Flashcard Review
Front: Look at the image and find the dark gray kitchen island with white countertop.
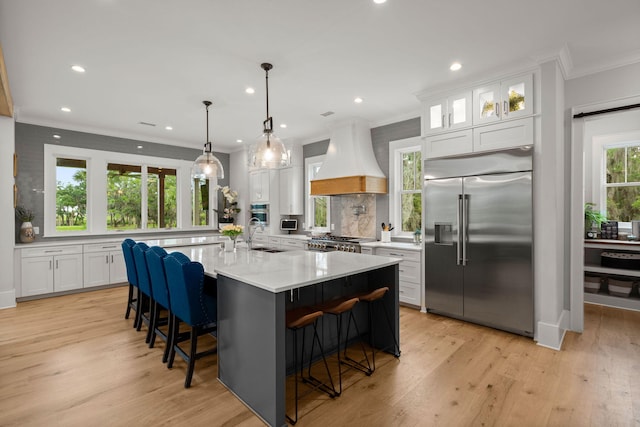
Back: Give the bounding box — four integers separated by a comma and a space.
170, 246, 401, 426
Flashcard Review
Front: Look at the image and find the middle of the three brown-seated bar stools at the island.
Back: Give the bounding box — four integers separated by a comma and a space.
317, 297, 373, 396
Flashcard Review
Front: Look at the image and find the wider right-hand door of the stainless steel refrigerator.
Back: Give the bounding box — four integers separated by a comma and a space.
464, 172, 533, 336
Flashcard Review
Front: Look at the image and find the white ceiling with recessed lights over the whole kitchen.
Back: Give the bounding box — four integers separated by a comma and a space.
0, 0, 640, 151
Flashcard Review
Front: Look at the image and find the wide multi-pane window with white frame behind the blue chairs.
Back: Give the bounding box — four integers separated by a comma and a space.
43, 144, 217, 237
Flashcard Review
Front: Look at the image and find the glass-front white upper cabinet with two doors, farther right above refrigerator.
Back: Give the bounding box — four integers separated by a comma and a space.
473, 74, 533, 125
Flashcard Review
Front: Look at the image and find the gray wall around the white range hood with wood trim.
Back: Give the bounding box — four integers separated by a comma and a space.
302, 117, 420, 239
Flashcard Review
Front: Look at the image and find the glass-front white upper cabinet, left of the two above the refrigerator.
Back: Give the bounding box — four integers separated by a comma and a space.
422, 91, 472, 136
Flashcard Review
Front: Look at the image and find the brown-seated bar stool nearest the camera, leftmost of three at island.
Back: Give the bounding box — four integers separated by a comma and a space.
286, 307, 335, 424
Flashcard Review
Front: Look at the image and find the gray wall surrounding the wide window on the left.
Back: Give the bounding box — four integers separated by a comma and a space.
15, 123, 229, 242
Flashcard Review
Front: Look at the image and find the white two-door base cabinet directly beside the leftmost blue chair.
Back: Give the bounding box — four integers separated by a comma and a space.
83, 243, 127, 288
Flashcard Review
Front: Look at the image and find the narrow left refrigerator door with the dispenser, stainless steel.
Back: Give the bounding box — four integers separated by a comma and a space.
425, 178, 463, 316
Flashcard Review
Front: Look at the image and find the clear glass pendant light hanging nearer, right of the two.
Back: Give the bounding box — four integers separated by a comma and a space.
249, 63, 289, 169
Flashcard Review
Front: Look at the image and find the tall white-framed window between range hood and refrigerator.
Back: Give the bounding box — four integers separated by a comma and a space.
389, 138, 422, 237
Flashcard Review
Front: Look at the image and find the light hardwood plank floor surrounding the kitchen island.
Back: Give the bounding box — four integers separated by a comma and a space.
0, 287, 640, 426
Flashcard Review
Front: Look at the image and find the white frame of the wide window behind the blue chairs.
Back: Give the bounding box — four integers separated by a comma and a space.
43, 144, 218, 237
